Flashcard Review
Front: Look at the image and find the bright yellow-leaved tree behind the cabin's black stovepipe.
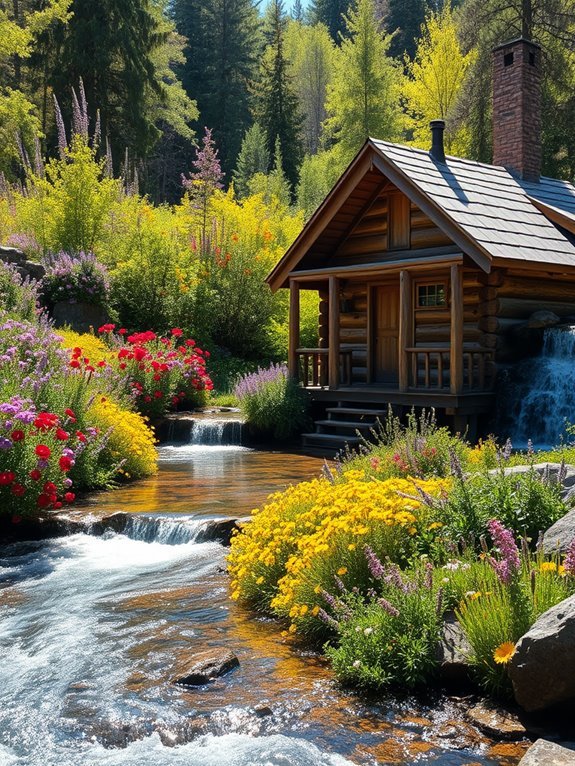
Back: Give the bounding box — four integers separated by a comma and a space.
402, 3, 475, 156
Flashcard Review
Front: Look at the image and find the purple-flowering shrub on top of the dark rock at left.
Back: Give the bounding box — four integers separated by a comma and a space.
40, 252, 110, 306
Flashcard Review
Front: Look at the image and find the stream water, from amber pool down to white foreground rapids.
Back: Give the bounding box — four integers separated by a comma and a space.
0, 424, 519, 766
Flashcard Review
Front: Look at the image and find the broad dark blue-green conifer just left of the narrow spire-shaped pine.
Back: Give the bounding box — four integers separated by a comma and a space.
173, 0, 260, 173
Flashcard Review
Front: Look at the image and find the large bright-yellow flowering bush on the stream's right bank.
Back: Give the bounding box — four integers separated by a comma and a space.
228, 470, 450, 632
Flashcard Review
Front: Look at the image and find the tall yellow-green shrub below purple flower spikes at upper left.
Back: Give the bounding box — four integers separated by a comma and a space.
18, 136, 120, 253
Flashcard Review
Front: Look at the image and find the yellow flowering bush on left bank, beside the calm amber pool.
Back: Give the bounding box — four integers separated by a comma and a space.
88, 396, 158, 479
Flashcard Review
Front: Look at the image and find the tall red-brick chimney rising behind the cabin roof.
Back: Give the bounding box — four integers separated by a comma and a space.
493, 38, 541, 182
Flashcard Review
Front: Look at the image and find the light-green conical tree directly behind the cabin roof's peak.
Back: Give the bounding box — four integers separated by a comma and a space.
326, 0, 401, 160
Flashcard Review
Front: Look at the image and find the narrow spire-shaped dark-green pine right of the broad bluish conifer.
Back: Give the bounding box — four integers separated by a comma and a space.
255, 0, 301, 187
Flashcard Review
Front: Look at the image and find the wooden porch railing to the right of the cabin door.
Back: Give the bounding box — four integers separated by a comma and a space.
406, 347, 494, 391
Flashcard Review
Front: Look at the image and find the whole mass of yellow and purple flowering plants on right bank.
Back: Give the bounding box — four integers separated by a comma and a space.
228, 413, 575, 700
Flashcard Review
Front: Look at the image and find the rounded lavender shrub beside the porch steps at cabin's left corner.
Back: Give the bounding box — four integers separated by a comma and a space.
234, 364, 307, 439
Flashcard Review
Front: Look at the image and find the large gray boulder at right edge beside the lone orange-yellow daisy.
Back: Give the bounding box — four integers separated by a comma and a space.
508, 596, 575, 713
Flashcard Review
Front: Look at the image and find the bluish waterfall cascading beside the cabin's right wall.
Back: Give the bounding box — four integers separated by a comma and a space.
511, 326, 575, 448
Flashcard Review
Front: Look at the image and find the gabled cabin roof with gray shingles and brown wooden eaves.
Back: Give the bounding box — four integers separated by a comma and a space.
267, 139, 575, 289
